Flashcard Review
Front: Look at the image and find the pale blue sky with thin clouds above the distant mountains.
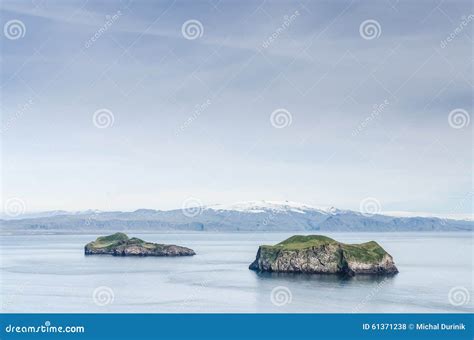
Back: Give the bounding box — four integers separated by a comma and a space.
0, 0, 474, 214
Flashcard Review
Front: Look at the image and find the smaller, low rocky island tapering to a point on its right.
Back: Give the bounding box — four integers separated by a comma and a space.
84, 233, 196, 256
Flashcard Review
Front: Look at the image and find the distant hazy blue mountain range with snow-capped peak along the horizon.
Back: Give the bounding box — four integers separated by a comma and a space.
0, 201, 474, 233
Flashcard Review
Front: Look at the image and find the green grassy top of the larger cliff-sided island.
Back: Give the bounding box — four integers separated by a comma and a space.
262, 235, 387, 262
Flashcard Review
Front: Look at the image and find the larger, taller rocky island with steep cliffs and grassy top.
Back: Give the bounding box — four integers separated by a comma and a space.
249, 235, 398, 276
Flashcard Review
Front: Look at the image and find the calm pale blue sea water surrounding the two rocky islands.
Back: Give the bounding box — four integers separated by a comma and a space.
0, 233, 474, 313
